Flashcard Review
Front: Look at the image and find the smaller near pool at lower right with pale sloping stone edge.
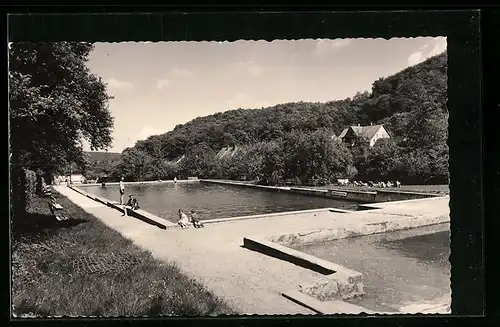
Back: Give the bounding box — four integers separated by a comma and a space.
294, 224, 451, 312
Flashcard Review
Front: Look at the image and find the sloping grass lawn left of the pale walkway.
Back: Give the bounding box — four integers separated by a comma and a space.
12, 194, 235, 316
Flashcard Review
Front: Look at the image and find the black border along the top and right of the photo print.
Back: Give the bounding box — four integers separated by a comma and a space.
8, 7, 485, 325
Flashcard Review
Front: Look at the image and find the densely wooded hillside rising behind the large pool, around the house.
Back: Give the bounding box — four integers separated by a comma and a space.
107, 52, 448, 183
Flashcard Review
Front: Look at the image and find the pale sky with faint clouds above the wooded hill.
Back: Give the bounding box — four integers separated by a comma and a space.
85, 37, 446, 152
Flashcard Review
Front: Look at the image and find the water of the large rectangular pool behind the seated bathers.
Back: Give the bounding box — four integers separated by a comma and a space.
82, 182, 358, 222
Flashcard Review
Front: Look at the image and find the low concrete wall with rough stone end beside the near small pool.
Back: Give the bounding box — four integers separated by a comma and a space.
243, 237, 364, 301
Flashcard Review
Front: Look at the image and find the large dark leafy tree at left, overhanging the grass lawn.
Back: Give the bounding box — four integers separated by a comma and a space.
9, 42, 113, 179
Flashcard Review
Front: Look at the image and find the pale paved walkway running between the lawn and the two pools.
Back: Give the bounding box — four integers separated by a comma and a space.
55, 186, 449, 314
